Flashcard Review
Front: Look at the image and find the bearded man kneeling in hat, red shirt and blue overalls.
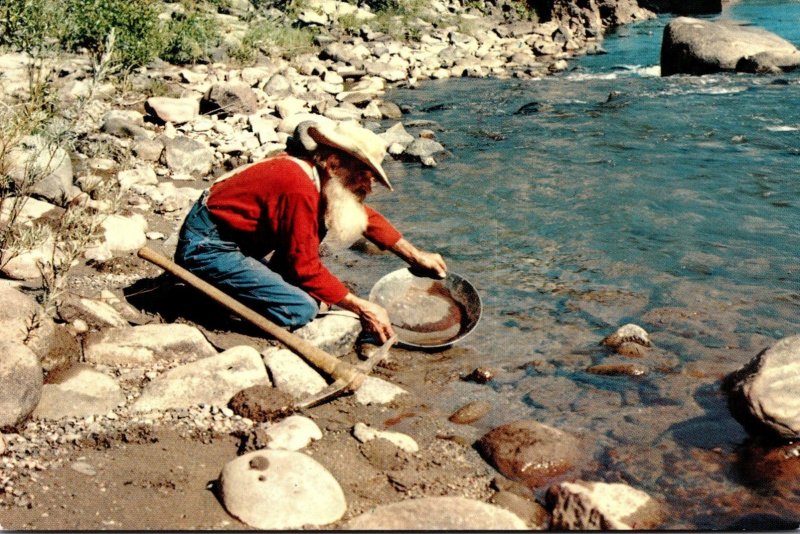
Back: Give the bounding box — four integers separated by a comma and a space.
175, 122, 447, 342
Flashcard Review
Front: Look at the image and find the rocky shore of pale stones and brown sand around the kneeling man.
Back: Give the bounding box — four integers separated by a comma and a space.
0, 0, 798, 530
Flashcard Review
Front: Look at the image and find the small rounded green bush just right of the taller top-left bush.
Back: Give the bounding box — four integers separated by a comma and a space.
161, 10, 221, 64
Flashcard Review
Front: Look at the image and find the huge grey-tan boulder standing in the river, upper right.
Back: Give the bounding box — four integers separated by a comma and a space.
661, 17, 800, 76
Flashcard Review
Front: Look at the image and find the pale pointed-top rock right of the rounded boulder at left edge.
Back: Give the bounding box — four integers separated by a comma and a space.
33, 364, 125, 419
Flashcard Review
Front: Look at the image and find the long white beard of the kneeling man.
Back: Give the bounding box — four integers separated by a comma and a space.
322, 176, 367, 250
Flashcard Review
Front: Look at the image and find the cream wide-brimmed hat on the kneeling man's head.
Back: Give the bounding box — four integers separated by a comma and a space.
294, 121, 394, 191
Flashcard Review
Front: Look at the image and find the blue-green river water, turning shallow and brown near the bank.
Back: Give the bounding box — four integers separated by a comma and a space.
346, 0, 800, 529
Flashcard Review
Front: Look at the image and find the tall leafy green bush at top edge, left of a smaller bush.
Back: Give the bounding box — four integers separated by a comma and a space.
62, 0, 163, 69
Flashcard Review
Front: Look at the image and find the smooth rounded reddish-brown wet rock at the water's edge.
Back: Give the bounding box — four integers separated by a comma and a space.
476, 420, 582, 488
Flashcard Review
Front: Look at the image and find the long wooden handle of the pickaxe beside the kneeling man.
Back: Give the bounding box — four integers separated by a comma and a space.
138, 247, 365, 389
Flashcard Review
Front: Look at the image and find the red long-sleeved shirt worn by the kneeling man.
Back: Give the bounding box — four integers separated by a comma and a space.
207, 156, 402, 304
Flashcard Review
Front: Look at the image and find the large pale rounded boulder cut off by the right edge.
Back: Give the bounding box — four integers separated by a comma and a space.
723, 335, 800, 439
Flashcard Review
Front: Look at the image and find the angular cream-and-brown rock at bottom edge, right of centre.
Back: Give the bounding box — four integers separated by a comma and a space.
547, 481, 662, 530
